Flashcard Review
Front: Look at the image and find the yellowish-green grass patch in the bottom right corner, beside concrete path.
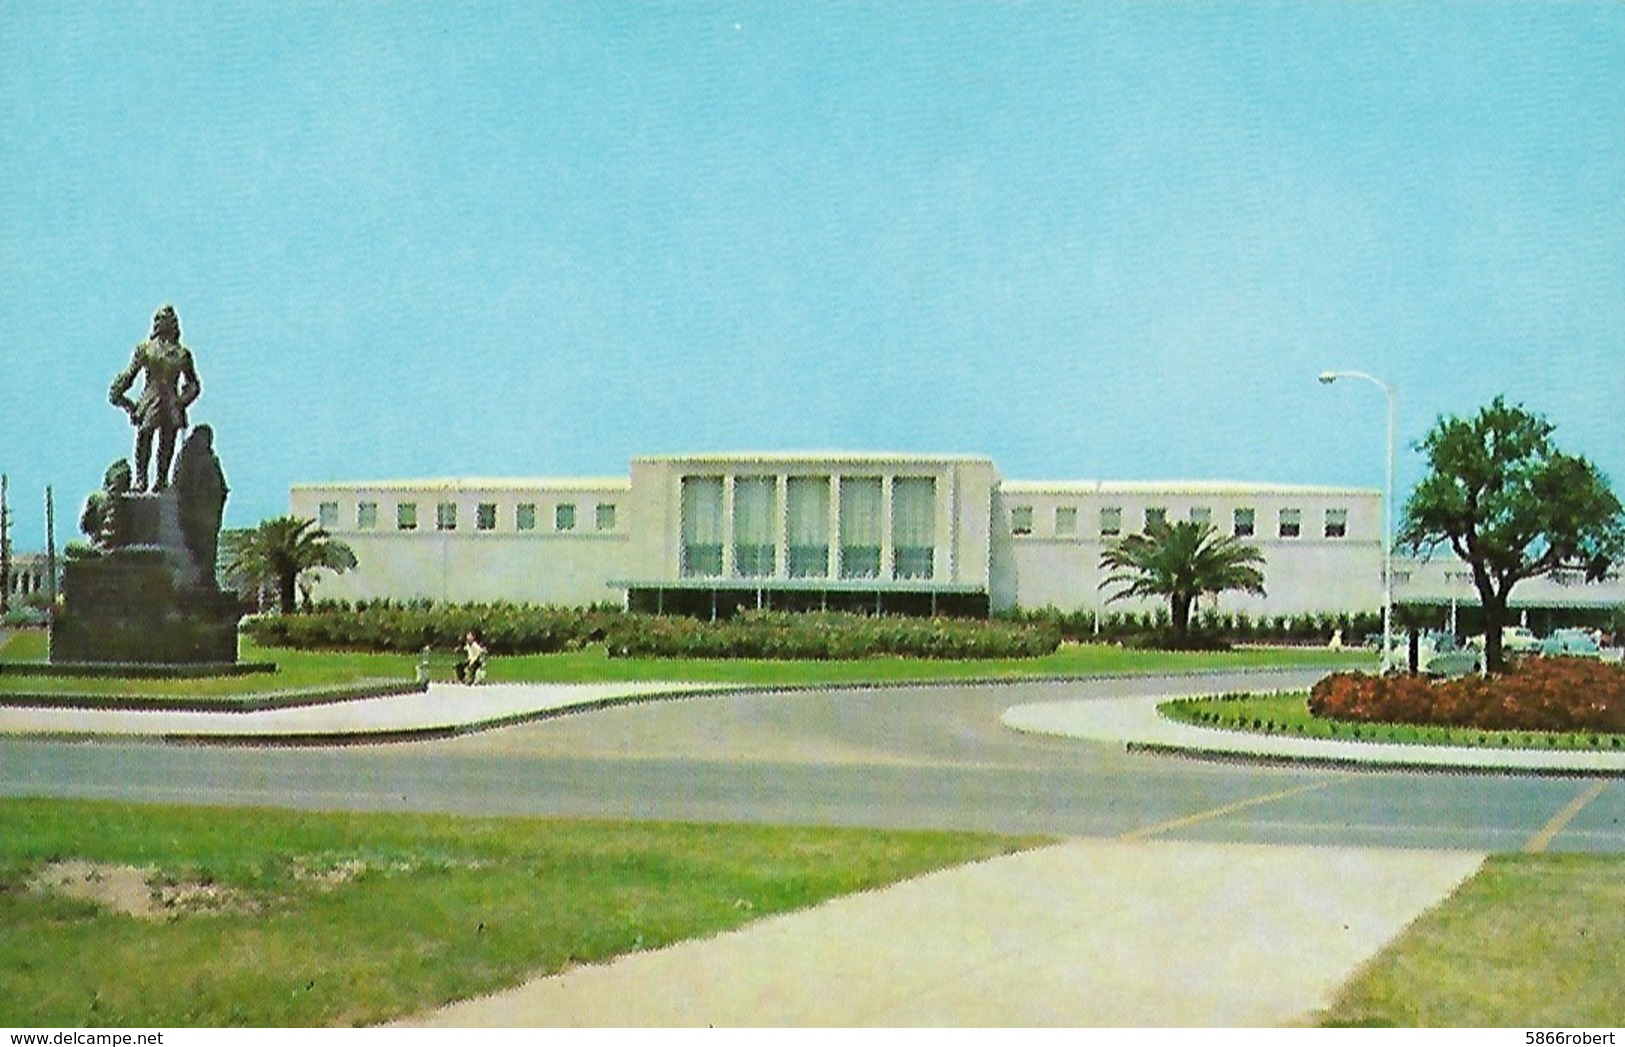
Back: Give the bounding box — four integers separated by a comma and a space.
1321, 854, 1625, 1020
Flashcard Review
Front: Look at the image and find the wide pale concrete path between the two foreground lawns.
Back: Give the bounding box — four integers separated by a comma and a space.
403, 841, 1482, 1027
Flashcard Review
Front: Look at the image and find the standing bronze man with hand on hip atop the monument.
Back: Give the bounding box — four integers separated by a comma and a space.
107, 306, 203, 491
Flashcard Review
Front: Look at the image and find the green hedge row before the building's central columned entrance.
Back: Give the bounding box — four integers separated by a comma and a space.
608, 611, 1061, 660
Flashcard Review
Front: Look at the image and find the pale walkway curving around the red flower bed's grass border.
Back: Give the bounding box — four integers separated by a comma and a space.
1001, 696, 1625, 775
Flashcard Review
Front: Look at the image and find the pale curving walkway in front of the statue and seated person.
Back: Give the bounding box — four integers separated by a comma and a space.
0, 681, 733, 745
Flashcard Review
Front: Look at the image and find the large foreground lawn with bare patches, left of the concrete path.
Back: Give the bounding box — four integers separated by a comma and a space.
0, 800, 1042, 1027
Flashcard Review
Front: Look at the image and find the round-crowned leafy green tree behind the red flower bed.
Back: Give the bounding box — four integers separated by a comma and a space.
1399, 397, 1625, 671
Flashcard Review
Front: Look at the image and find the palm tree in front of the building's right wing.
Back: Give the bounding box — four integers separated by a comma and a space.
1100, 520, 1264, 642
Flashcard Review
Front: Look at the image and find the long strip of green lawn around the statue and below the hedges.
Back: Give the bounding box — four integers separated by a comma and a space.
0, 632, 1375, 696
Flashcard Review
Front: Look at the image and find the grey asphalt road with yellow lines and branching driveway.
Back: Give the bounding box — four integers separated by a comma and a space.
0, 673, 1625, 852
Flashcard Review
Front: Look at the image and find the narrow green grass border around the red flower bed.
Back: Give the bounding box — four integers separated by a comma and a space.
1159, 693, 1625, 751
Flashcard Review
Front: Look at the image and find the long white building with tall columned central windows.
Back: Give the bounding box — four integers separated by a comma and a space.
291, 454, 1625, 616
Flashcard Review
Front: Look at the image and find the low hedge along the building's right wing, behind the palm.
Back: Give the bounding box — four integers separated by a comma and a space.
1004, 606, 1383, 647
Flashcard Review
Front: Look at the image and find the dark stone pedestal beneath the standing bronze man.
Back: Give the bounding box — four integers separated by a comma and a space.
50, 489, 237, 665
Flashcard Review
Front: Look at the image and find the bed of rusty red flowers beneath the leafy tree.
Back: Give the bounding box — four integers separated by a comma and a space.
1310, 658, 1625, 733
